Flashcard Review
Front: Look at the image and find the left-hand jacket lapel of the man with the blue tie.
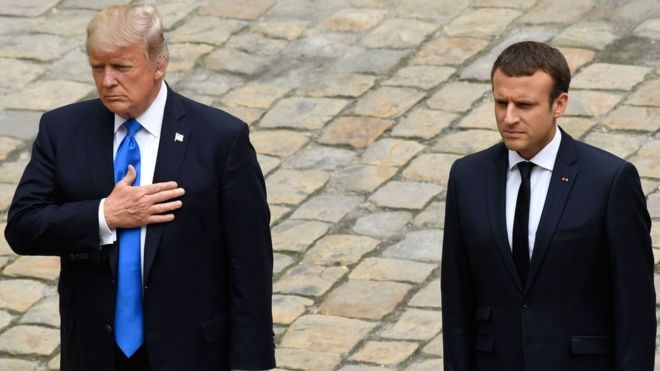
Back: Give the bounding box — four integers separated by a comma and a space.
85, 102, 118, 276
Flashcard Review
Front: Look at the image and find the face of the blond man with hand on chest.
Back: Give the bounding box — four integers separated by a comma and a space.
88, 45, 167, 119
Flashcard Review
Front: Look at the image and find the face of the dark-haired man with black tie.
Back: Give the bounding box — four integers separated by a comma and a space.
493, 69, 568, 160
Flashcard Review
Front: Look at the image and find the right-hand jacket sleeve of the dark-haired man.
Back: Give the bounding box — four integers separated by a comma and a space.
607, 162, 656, 371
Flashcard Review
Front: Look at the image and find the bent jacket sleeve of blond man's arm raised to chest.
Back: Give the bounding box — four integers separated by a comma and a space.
5, 115, 100, 256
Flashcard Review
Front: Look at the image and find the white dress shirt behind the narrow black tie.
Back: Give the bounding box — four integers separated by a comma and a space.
506, 126, 561, 260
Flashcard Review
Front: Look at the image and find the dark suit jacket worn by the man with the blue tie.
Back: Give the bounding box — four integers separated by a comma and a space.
6, 88, 275, 371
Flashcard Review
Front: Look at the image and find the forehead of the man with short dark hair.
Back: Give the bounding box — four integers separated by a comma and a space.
492, 69, 554, 96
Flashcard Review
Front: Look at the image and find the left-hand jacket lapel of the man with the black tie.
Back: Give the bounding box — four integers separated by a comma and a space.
486, 144, 523, 292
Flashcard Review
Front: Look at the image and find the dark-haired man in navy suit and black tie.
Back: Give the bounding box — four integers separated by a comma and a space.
441, 42, 656, 371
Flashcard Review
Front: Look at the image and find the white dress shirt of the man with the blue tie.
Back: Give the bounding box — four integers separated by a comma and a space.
99, 82, 167, 280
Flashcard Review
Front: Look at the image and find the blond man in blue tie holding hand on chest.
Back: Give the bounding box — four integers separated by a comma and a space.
5, 5, 275, 371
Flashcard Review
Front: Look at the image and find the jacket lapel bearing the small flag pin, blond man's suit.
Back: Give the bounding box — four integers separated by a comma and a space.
144, 86, 190, 282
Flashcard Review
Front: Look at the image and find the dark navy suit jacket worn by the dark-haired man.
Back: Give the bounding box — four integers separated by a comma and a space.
441, 132, 656, 371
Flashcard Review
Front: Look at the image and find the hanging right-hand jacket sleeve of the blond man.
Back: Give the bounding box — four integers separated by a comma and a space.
222, 125, 275, 370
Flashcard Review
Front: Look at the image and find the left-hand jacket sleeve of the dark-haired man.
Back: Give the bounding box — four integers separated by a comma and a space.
441, 162, 474, 371
